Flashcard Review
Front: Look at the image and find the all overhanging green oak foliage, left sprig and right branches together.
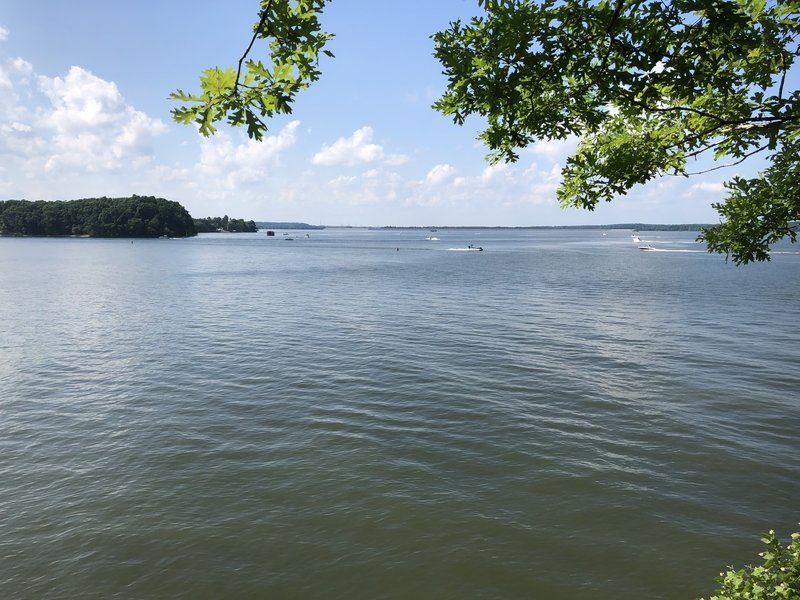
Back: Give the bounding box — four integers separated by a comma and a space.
172, 0, 800, 263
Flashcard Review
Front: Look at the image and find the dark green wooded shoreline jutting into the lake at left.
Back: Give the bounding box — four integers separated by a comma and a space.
0, 194, 258, 238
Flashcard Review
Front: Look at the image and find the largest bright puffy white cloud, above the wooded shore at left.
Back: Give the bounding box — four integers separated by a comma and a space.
38, 67, 166, 171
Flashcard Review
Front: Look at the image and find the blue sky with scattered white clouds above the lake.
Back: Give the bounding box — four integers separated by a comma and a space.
0, 0, 764, 227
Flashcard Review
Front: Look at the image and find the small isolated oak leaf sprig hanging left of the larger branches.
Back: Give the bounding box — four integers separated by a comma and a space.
170, 0, 333, 140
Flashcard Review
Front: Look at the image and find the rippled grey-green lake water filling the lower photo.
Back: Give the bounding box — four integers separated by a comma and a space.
0, 229, 800, 600
